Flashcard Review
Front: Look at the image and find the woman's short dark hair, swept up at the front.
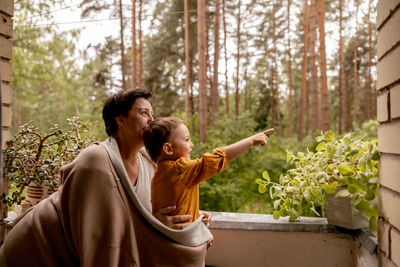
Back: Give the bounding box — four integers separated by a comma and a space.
103, 88, 153, 136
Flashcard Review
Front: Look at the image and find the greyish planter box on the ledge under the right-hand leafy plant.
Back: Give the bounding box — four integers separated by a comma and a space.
325, 194, 369, 229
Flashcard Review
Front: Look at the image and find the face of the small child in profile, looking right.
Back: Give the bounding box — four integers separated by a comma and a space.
171, 124, 193, 160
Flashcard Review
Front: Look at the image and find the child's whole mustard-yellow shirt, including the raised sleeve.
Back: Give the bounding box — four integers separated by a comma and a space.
151, 147, 229, 222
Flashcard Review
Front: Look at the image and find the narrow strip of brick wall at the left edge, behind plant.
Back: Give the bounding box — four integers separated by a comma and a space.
0, 0, 14, 244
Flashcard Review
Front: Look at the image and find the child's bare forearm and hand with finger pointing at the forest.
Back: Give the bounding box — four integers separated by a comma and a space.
225, 128, 274, 161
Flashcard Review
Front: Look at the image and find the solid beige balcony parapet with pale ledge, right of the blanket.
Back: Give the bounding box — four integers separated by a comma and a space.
206, 212, 378, 267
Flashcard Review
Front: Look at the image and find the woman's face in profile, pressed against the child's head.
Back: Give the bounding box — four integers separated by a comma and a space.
117, 97, 153, 143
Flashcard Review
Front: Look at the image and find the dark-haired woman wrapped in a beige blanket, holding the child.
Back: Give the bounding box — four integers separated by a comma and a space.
0, 89, 211, 266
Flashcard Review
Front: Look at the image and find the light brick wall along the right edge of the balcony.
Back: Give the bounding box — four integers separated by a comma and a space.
376, 0, 400, 266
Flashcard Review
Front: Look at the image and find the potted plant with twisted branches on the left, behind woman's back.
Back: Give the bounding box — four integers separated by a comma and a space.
3, 117, 93, 214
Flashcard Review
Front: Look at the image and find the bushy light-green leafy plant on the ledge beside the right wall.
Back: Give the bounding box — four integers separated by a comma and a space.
256, 131, 379, 236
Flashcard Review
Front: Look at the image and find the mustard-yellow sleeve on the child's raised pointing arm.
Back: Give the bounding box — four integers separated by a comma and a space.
176, 147, 229, 186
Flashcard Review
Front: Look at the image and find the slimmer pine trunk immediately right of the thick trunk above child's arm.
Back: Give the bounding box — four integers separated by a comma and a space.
211, 0, 220, 114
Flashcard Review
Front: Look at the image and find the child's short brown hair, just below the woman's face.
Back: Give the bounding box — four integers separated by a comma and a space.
142, 117, 184, 162
